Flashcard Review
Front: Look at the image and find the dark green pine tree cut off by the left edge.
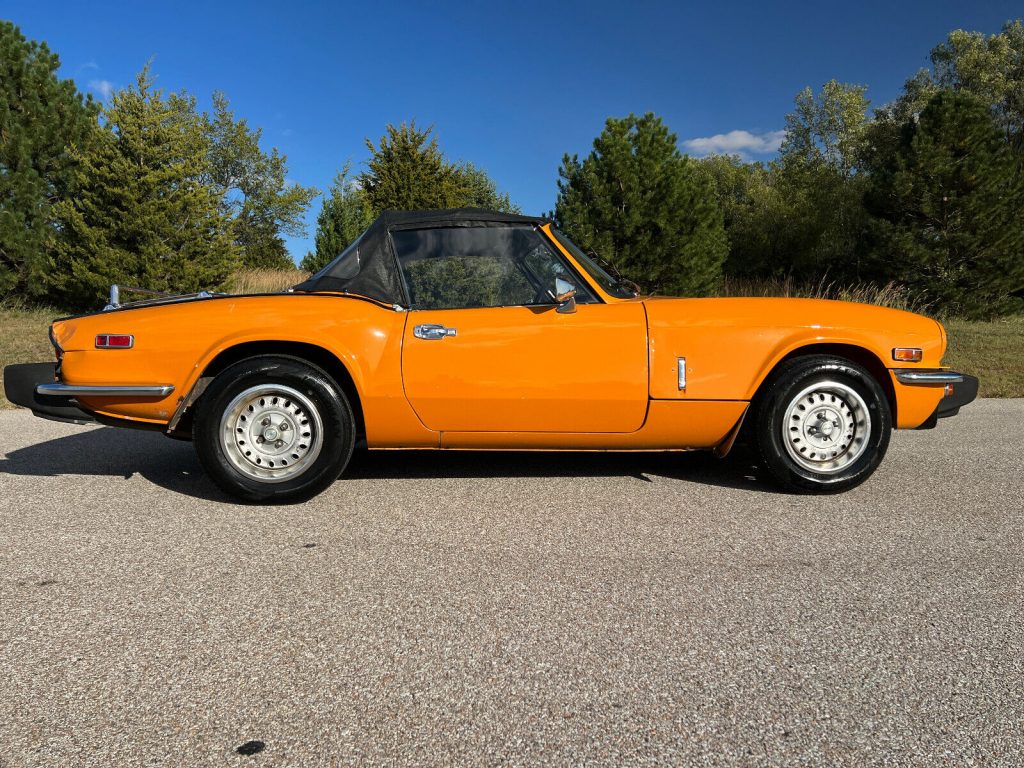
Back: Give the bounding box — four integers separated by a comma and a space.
0, 22, 97, 297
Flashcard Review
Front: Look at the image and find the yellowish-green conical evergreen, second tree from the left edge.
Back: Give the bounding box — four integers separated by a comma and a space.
50, 70, 239, 307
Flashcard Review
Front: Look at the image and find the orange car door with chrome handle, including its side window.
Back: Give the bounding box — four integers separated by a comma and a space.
392, 226, 647, 432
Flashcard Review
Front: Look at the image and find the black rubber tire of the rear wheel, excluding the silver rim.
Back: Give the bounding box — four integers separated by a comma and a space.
193, 356, 355, 504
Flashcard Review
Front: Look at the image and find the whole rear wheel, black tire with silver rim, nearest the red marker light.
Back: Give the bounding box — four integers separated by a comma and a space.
193, 356, 355, 504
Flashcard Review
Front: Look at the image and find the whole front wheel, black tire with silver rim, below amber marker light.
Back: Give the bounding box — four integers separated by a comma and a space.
752, 355, 892, 494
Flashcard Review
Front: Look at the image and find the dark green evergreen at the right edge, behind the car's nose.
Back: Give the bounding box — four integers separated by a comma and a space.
868, 90, 1024, 317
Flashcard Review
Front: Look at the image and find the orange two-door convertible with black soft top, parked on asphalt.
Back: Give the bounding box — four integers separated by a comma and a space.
5, 209, 978, 502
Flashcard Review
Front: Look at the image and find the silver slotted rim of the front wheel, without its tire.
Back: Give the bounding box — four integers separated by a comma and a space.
781, 381, 871, 474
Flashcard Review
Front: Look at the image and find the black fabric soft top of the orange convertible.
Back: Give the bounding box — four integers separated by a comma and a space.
292, 208, 547, 306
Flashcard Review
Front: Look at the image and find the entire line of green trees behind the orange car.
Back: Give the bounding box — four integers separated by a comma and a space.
0, 20, 1024, 316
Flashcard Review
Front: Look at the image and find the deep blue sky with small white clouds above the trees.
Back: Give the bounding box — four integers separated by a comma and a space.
8, 0, 1024, 259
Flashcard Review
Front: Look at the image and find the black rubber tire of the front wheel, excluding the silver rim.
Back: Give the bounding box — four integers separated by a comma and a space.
758, 357, 892, 494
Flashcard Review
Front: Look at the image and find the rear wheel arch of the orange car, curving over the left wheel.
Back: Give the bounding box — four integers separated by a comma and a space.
167, 340, 366, 439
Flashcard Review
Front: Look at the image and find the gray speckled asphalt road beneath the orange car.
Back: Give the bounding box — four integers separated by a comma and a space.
0, 400, 1024, 766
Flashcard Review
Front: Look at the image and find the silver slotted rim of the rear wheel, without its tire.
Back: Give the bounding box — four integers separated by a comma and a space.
220, 384, 324, 482
